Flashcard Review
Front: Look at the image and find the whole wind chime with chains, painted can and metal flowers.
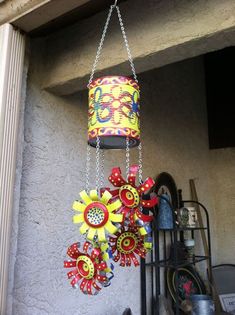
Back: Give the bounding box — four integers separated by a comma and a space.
64, 0, 158, 295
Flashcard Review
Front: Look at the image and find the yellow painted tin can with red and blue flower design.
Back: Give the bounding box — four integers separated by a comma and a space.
88, 76, 140, 149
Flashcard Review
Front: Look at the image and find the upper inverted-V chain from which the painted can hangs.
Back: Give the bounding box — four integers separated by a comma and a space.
87, 1, 138, 88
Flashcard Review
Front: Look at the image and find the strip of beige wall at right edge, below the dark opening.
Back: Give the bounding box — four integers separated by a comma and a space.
209, 148, 235, 264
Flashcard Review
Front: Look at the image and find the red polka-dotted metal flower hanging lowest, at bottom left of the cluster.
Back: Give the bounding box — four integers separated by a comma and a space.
64, 242, 113, 295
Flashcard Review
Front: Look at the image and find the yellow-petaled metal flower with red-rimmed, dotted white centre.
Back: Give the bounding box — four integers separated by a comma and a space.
73, 190, 123, 242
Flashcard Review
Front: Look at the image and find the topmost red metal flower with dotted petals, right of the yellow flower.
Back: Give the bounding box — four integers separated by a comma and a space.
109, 164, 158, 235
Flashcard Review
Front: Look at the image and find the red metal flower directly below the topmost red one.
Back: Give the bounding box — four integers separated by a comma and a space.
109, 226, 150, 267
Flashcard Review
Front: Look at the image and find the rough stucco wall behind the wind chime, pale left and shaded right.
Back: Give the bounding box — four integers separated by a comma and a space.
9, 43, 214, 315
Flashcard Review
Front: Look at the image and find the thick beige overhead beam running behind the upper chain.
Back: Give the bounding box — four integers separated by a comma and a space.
42, 0, 235, 95
